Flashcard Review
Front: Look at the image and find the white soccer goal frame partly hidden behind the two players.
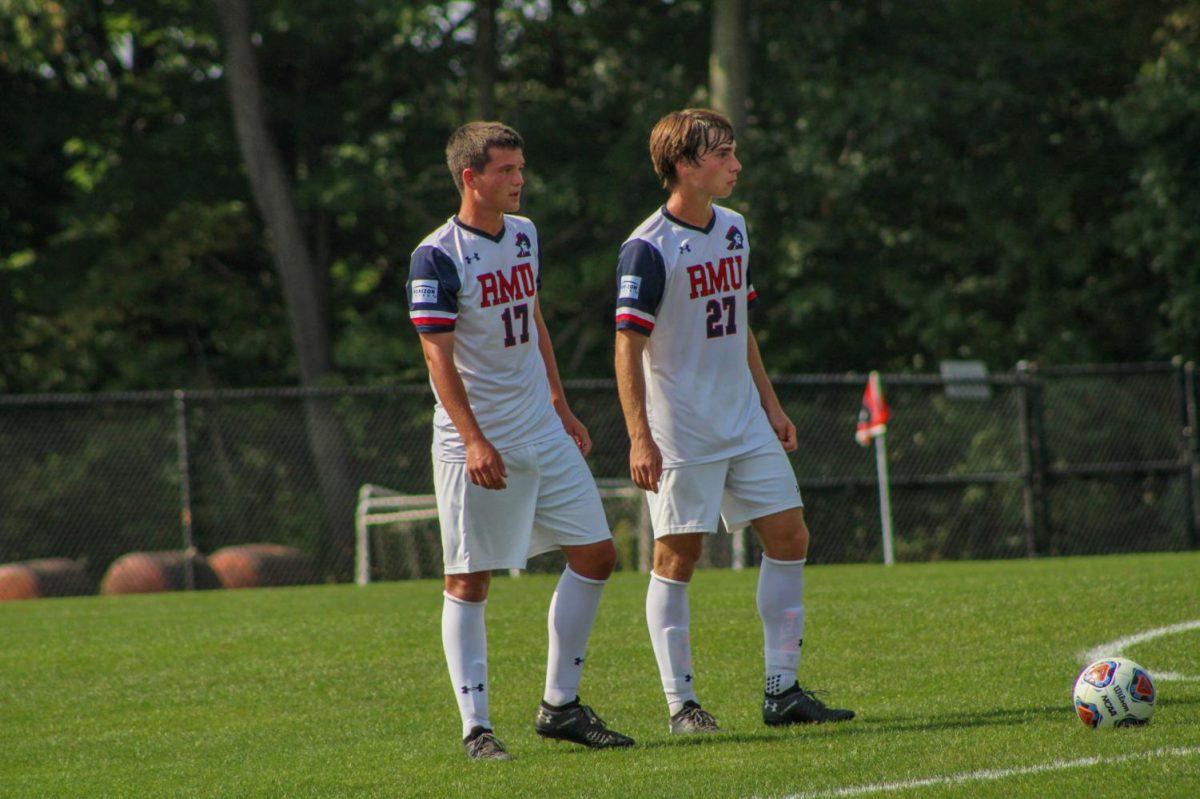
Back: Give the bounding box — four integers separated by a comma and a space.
354, 479, 745, 585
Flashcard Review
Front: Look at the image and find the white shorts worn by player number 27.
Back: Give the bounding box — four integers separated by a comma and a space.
646, 441, 804, 539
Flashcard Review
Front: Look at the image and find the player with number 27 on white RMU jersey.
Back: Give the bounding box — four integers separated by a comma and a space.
616, 109, 854, 734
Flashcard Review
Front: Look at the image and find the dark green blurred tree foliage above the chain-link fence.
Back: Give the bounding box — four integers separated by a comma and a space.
0, 0, 1200, 394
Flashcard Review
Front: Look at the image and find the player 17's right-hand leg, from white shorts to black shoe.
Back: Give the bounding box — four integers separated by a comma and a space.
530, 435, 634, 749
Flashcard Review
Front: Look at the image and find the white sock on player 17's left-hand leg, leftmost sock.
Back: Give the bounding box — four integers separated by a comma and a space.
442, 591, 492, 738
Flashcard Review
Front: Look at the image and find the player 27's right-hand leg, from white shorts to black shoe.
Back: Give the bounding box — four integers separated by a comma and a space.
724, 444, 854, 725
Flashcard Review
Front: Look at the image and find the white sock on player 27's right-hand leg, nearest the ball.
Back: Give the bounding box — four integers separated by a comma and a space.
756, 555, 804, 693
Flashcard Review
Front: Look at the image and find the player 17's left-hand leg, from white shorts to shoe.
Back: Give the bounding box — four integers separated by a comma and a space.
433, 443, 534, 759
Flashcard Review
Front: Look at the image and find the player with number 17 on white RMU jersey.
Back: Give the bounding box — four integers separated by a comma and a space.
407, 122, 634, 761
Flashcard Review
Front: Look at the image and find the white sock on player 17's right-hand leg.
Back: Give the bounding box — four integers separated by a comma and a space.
541, 566, 605, 705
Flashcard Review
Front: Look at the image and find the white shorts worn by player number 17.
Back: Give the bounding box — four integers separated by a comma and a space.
433, 432, 612, 575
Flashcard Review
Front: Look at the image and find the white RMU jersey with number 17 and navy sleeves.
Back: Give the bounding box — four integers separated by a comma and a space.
407, 215, 563, 461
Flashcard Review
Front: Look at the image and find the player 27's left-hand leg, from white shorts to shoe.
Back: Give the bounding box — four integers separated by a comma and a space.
646, 462, 727, 733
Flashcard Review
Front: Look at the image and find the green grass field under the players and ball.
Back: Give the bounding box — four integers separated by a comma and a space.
0, 553, 1200, 798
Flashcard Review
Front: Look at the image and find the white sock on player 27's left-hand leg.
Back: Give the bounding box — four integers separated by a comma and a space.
646, 571, 696, 715
